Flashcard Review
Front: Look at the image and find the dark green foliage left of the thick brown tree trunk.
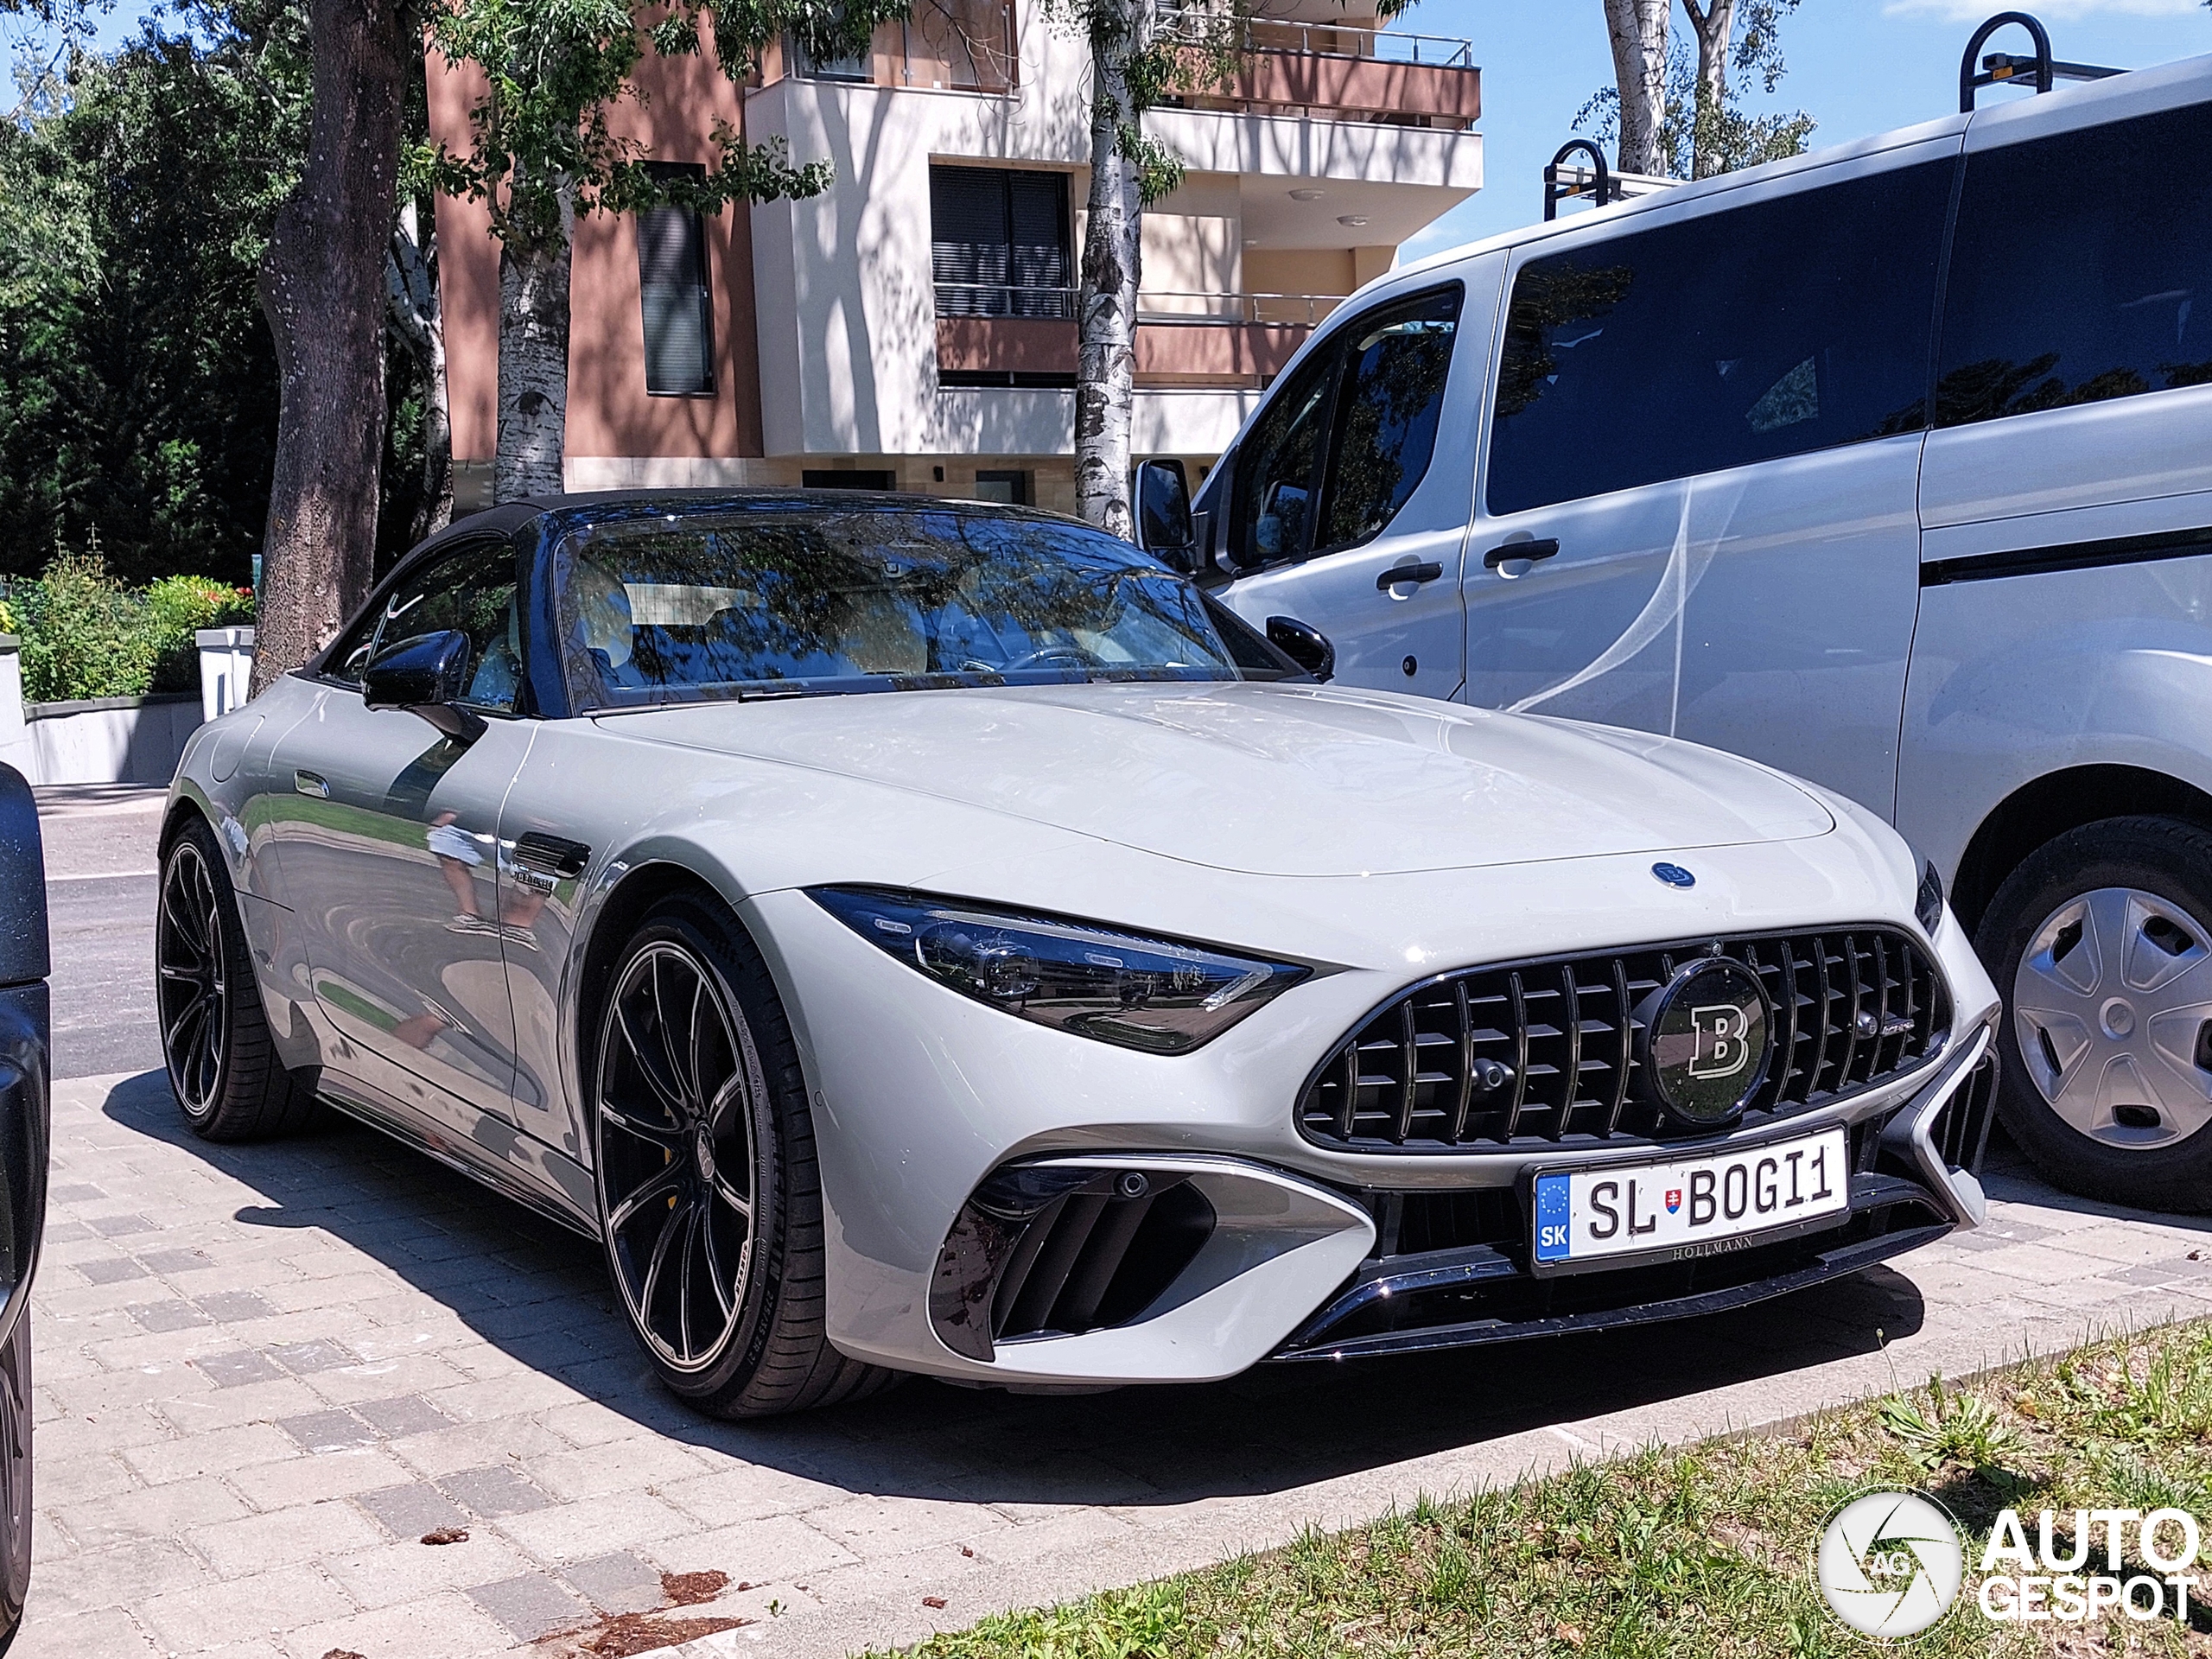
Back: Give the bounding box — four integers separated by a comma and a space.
0, 4, 305, 582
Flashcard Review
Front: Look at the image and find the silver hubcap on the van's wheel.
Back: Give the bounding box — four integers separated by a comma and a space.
2013, 887, 2212, 1150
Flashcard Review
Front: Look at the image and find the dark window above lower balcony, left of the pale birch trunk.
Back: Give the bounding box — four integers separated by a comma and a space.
929, 166, 1075, 319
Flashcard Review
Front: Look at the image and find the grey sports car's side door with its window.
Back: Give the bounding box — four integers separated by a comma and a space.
272, 537, 536, 1137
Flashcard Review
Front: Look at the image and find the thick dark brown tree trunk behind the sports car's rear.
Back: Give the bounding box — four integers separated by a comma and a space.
254, 0, 411, 692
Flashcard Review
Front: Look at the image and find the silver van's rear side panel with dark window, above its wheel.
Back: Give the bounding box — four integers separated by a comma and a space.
1897, 76, 2212, 875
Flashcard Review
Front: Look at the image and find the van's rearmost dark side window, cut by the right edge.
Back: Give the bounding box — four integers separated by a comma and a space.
1936, 104, 2212, 427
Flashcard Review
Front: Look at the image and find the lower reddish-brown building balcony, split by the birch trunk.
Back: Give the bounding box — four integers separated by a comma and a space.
938, 283, 1343, 390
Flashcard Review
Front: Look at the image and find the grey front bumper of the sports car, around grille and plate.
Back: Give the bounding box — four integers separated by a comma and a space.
746, 871, 1995, 1387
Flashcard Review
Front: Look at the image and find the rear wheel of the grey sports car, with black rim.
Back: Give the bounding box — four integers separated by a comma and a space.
153, 817, 316, 1141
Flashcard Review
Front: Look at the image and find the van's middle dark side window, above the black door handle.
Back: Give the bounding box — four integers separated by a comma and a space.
1486, 162, 1955, 515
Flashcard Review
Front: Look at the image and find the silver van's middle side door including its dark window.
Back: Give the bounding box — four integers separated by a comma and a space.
1466, 145, 1958, 814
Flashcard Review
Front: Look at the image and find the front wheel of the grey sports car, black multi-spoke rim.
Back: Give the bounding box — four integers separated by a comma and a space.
586, 896, 898, 1418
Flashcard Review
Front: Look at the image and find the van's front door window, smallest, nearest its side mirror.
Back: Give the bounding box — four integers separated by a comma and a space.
1230, 283, 1465, 569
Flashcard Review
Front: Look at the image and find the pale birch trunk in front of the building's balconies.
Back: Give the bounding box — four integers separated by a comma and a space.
1075, 19, 1144, 536
